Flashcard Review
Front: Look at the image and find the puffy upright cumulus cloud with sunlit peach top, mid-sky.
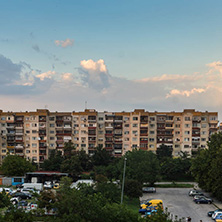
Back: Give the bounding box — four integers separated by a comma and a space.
78, 59, 111, 91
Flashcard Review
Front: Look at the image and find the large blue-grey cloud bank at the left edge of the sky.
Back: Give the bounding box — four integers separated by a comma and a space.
0, 55, 55, 95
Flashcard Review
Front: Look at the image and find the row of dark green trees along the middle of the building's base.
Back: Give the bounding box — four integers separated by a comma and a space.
41, 142, 192, 185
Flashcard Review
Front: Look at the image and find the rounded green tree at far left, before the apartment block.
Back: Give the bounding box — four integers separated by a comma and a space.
1, 155, 36, 176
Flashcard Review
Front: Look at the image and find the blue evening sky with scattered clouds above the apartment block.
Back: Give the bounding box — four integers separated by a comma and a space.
0, 0, 222, 119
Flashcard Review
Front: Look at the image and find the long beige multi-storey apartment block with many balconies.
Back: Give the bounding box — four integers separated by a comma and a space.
0, 109, 218, 163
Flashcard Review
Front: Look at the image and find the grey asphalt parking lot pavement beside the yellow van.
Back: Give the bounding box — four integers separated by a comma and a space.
140, 188, 217, 222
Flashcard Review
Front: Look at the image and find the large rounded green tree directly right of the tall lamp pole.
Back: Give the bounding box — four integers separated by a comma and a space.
125, 149, 160, 185
